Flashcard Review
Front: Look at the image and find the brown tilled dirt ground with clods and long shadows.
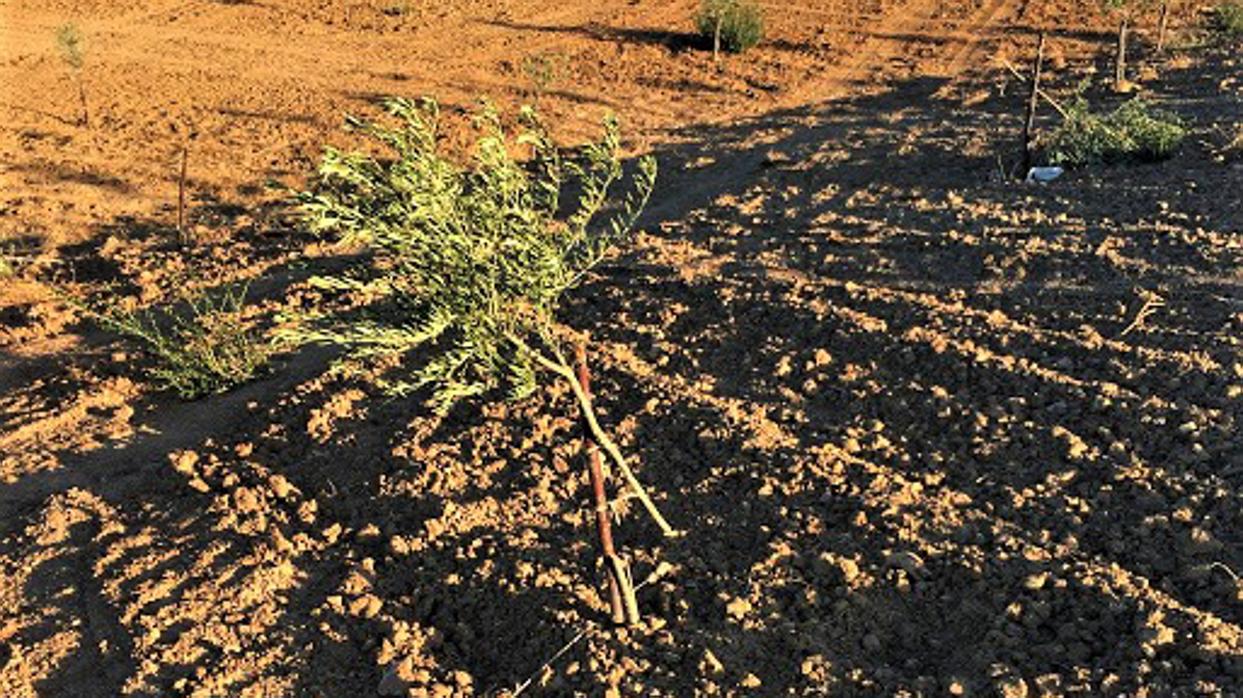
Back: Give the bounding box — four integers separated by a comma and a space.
0, 0, 1243, 697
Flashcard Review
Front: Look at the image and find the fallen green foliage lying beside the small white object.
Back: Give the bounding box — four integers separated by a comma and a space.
1047, 98, 1187, 166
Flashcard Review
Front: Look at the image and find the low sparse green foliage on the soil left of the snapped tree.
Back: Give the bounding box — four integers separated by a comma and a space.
77, 287, 278, 400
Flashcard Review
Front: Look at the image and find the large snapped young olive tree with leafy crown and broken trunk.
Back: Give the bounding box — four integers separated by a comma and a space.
298, 99, 674, 621
